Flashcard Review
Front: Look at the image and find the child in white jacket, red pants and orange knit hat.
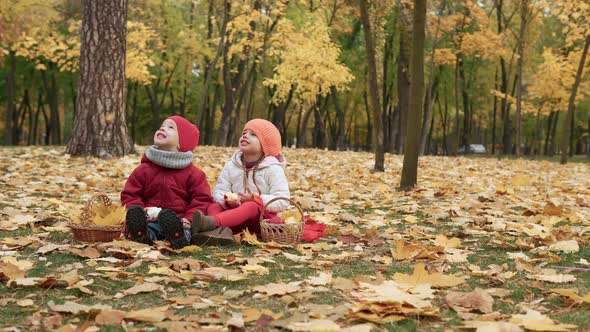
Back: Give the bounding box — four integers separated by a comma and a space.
192, 119, 290, 244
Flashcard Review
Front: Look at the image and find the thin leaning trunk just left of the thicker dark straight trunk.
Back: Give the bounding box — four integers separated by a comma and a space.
359, 0, 385, 172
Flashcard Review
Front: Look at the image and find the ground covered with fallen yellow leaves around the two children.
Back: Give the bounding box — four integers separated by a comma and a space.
0, 147, 590, 331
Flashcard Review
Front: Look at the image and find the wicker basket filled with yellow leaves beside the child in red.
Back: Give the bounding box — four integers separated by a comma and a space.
68, 195, 123, 242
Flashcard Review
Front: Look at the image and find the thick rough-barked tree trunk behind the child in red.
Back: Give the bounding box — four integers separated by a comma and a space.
66, 0, 133, 158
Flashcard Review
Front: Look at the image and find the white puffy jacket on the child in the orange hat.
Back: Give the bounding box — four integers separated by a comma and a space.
213, 151, 291, 213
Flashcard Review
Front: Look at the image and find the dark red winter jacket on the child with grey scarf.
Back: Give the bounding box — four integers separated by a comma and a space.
121, 155, 213, 221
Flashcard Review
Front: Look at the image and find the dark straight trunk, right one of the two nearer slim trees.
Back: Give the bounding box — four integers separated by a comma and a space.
400, 0, 426, 190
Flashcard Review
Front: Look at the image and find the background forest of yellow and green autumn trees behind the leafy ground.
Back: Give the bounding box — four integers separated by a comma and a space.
0, 0, 590, 156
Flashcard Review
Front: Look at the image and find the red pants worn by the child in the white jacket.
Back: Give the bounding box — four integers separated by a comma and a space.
207, 202, 267, 234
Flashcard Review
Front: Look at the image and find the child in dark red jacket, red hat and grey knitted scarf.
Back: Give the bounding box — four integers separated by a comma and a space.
121, 116, 212, 249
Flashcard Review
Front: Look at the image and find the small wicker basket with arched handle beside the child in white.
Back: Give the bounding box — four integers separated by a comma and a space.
260, 197, 304, 244
